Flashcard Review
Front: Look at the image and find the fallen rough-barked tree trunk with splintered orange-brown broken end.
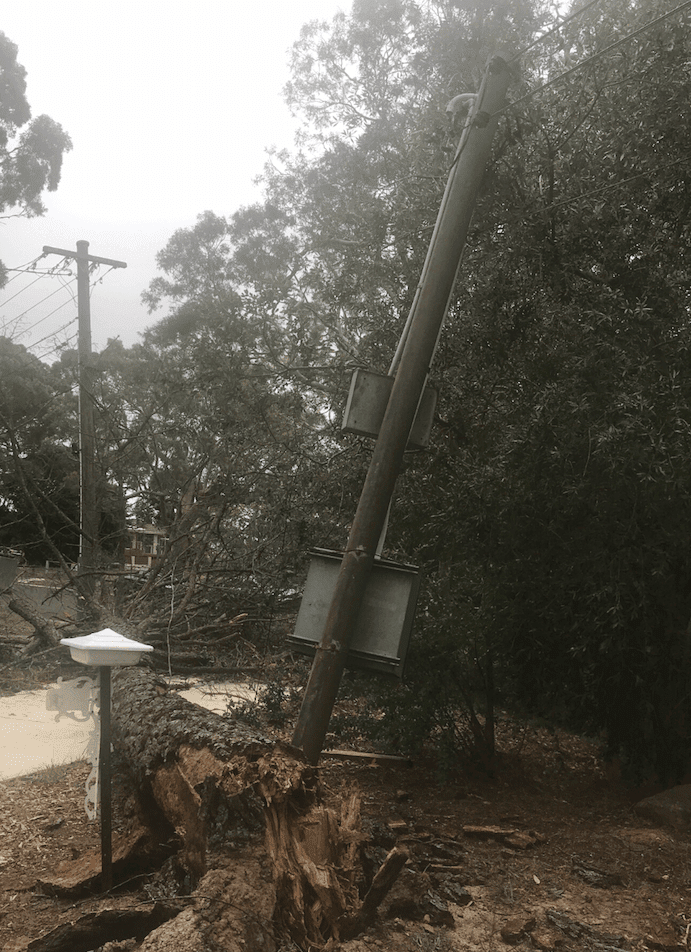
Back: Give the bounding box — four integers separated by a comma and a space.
112, 668, 405, 949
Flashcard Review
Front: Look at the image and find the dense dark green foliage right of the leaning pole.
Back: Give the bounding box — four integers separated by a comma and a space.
384, 4, 691, 777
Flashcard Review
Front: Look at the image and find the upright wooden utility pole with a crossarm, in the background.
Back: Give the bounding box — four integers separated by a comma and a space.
43, 241, 127, 593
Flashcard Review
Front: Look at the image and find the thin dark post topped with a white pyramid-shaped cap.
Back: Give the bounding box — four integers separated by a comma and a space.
60, 628, 154, 892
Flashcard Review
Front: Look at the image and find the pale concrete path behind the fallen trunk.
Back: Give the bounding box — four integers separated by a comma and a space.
0, 682, 255, 780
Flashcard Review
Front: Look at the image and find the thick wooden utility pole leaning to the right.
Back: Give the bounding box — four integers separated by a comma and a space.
293, 57, 512, 764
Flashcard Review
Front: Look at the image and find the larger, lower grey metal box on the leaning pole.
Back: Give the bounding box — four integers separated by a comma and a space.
289, 549, 420, 678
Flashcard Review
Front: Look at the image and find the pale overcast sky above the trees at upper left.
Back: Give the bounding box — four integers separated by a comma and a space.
0, 0, 351, 359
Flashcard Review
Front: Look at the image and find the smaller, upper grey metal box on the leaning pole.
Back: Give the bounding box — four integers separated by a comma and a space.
341, 369, 437, 450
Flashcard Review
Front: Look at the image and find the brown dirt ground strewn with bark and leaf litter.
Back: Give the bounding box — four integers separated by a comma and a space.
0, 672, 691, 952
